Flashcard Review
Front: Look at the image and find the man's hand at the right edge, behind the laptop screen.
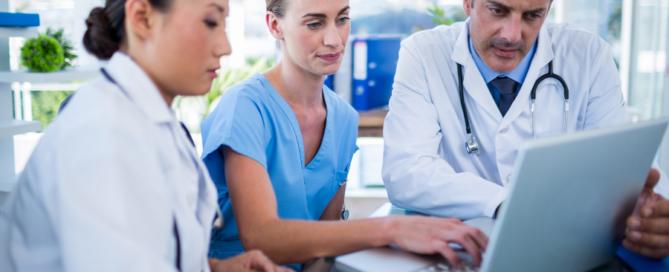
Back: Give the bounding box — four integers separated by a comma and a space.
623, 169, 669, 259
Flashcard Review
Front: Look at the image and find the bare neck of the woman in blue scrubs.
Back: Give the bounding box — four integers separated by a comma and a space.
265, 59, 325, 108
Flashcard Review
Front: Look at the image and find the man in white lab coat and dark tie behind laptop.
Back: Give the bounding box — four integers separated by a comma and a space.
383, 0, 669, 258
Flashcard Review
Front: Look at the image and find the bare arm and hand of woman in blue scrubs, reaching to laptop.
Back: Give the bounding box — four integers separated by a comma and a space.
224, 147, 488, 266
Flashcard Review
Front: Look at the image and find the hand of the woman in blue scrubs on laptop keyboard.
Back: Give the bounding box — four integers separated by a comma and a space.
387, 216, 488, 268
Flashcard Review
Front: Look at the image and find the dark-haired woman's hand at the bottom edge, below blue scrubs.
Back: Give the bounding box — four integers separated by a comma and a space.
209, 250, 293, 272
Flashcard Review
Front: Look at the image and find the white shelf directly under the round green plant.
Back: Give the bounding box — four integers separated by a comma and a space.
0, 67, 100, 83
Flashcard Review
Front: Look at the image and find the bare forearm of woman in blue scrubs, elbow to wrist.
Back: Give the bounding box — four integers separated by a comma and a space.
240, 218, 392, 264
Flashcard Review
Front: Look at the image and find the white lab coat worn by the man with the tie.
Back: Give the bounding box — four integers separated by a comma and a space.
382, 21, 667, 219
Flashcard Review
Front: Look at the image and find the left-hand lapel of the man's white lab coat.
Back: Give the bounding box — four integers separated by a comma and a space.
451, 19, 502, 123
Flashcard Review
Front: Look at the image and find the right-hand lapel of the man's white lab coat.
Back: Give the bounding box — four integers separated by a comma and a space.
499, 24, 557, 130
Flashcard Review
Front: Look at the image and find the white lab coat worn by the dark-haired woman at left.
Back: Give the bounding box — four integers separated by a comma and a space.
0, 53, 217, 272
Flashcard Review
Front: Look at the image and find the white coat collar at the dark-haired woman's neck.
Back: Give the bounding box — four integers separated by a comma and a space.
105, 52, 176, 123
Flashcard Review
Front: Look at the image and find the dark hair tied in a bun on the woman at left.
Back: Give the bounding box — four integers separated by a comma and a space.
84, 0, 174, 60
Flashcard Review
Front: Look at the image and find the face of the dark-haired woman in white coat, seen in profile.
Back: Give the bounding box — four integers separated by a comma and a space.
143, 0, 231, 96
